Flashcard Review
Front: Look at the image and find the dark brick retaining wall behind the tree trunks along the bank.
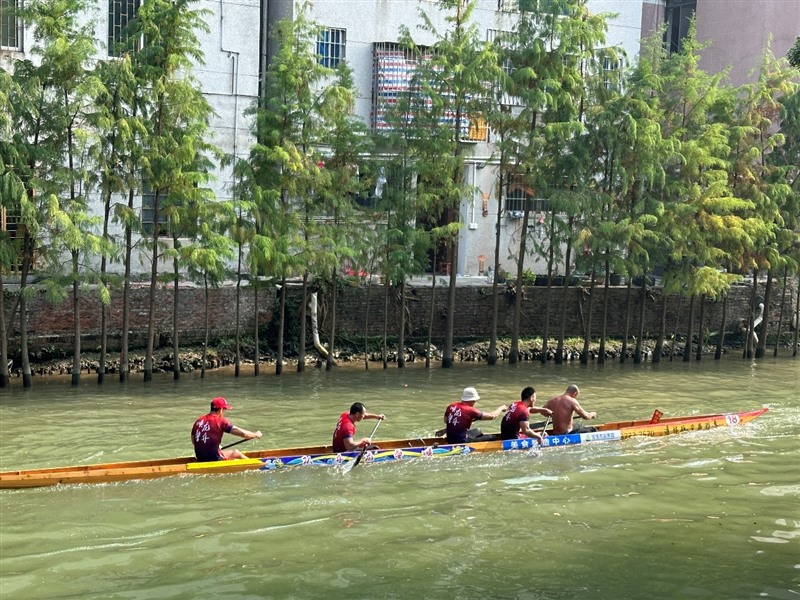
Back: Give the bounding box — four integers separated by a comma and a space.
4, 285, 792, 353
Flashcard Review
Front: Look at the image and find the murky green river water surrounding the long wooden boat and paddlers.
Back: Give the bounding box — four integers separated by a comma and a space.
0, 357, 800, 600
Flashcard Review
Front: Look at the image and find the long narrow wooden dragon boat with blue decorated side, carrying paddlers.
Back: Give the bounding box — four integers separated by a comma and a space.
0, 408, 768, 489
